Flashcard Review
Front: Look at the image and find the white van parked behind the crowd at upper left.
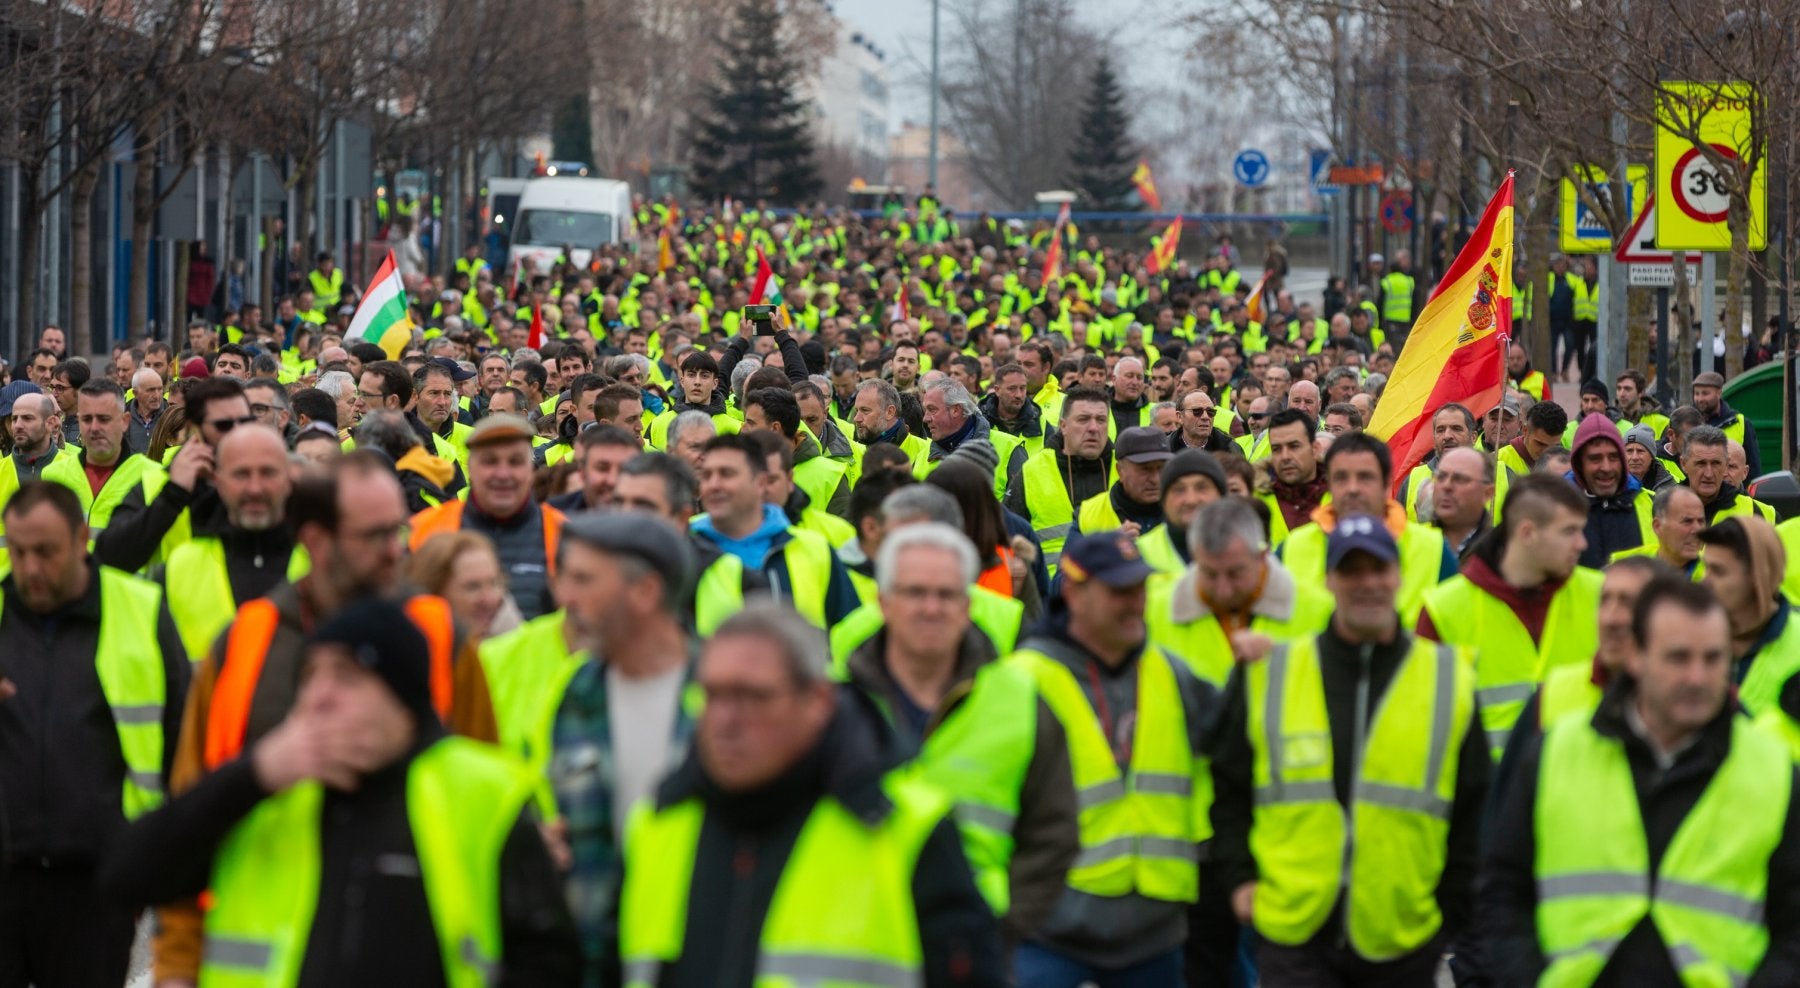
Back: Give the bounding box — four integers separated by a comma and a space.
508, 178, 637, 274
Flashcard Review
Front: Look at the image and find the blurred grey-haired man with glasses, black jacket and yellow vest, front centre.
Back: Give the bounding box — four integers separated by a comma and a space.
614, 605, 1000, 984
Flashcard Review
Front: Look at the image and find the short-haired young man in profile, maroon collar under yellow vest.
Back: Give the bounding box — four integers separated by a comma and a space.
1418, 475, 1611, 758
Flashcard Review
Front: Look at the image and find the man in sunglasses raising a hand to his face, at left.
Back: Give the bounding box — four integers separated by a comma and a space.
94, 376, 256, 572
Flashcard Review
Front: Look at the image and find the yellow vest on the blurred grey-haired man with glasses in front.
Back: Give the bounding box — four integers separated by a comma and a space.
619, 768, 949, 988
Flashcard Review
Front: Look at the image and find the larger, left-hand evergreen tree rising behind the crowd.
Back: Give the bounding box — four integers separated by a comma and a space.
689, 0, 821, 205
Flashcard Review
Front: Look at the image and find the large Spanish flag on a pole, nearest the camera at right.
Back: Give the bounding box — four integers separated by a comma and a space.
1368, 171, 1512, 490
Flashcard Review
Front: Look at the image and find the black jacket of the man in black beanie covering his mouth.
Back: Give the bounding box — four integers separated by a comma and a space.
99, 727, 581, 988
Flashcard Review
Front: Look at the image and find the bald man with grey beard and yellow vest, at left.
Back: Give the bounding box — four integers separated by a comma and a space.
164, 423, 301, 662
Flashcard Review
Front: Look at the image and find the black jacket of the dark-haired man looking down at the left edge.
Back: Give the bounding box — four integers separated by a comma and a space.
0, 563, 189, 867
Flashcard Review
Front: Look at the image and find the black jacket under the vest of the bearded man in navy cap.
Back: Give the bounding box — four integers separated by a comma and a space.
1213, 628, 1490, 945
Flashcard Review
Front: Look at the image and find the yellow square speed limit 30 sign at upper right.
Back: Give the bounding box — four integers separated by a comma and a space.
1656, 83, 1768, 250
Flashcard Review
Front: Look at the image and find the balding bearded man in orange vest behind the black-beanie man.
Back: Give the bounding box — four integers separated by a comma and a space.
155, 452, 497, 983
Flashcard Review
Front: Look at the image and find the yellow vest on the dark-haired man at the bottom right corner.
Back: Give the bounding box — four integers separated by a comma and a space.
1534, 716, 1793, 988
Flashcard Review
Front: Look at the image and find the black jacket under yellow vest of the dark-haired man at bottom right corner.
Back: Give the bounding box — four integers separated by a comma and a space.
1478, 677, 1800, 988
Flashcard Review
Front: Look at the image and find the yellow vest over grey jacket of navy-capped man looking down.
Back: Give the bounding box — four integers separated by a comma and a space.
1006, 639, 1213, 902
